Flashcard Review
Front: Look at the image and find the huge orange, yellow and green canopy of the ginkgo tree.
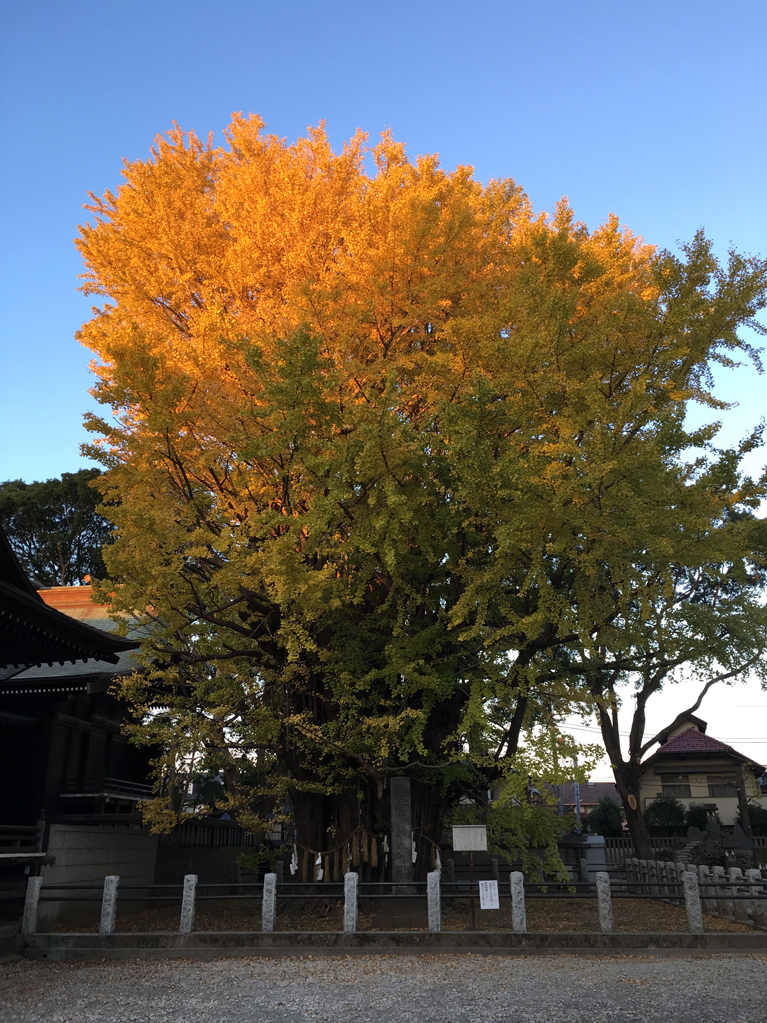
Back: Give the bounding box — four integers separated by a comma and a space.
78, 117, 765, 871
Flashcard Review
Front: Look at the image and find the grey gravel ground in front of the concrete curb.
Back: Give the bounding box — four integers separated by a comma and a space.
0, 954, 767, 1023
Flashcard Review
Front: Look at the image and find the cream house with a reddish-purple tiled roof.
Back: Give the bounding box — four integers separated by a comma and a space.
639, 716, 764, 825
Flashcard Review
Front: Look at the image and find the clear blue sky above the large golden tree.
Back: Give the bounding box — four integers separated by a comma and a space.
0, 0, 767, 480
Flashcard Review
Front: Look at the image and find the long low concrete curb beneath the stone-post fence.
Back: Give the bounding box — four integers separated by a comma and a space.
16, 931, 767, 962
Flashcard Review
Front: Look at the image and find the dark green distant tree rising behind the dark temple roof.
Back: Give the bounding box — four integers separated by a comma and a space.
0, 469, 111, 586
